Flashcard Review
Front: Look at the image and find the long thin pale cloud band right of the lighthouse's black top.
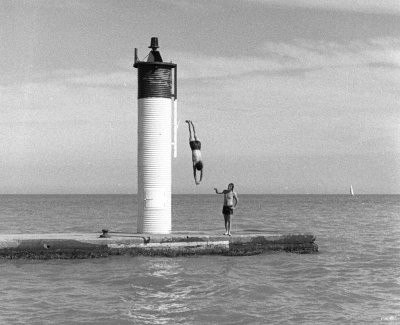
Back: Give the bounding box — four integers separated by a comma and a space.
171, 38, 400, 80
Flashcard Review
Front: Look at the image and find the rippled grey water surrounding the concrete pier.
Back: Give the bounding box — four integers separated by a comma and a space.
0, 195, 400, 324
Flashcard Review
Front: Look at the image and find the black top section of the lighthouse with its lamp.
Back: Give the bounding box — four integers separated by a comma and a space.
133, 37, 177, 99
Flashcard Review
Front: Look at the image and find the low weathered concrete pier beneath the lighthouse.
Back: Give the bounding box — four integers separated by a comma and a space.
0, 232, 318, 259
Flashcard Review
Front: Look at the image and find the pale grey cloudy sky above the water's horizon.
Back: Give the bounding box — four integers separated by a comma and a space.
0, 0, 400, 194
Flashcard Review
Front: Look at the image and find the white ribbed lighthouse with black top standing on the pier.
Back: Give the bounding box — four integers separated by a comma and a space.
133, 37, 177, 234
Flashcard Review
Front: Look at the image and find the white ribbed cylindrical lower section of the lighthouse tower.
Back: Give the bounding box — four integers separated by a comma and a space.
138, 97, 171, 233
